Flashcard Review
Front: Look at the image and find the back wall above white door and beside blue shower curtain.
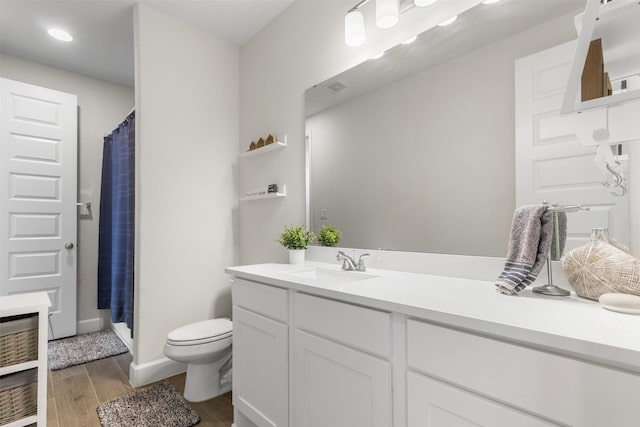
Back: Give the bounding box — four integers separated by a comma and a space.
0, 53, 134, 333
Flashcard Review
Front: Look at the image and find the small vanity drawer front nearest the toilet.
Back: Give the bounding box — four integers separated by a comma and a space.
231, 277, 289, 322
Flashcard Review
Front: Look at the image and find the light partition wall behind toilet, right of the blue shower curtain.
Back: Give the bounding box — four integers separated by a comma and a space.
134, 4, 239, 372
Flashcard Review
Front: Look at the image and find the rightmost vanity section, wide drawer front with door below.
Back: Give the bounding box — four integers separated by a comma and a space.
407, 320, 640, 427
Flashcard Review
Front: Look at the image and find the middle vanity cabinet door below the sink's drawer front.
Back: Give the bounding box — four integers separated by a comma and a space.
292, 330, 392, 427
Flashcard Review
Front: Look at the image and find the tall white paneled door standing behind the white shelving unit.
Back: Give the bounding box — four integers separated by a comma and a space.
0, 79, 77, 338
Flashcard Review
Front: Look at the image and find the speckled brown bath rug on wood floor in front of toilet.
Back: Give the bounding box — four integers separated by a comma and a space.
96, 383, 200, 427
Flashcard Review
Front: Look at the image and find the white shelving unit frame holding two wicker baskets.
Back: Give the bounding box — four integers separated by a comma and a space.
0, 292, 51, 427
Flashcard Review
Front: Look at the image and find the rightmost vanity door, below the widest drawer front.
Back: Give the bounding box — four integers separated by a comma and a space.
407, 372, 555, 427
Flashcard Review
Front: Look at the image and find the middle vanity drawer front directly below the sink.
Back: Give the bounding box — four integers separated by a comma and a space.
294, 293, 391, 359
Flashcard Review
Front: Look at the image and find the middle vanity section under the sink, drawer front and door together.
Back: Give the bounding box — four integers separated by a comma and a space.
292, 293, 392, 427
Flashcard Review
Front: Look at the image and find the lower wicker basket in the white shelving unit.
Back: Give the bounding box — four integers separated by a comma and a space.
0, 369, 38, 425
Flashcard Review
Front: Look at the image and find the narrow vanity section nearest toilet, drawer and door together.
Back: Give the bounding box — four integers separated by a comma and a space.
232, 278, 289, 427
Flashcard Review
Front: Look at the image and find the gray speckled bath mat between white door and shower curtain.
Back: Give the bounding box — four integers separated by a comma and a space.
49, 330, 129, 371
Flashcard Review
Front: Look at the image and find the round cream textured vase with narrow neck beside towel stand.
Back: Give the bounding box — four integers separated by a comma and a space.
562, 228, 640, 300
